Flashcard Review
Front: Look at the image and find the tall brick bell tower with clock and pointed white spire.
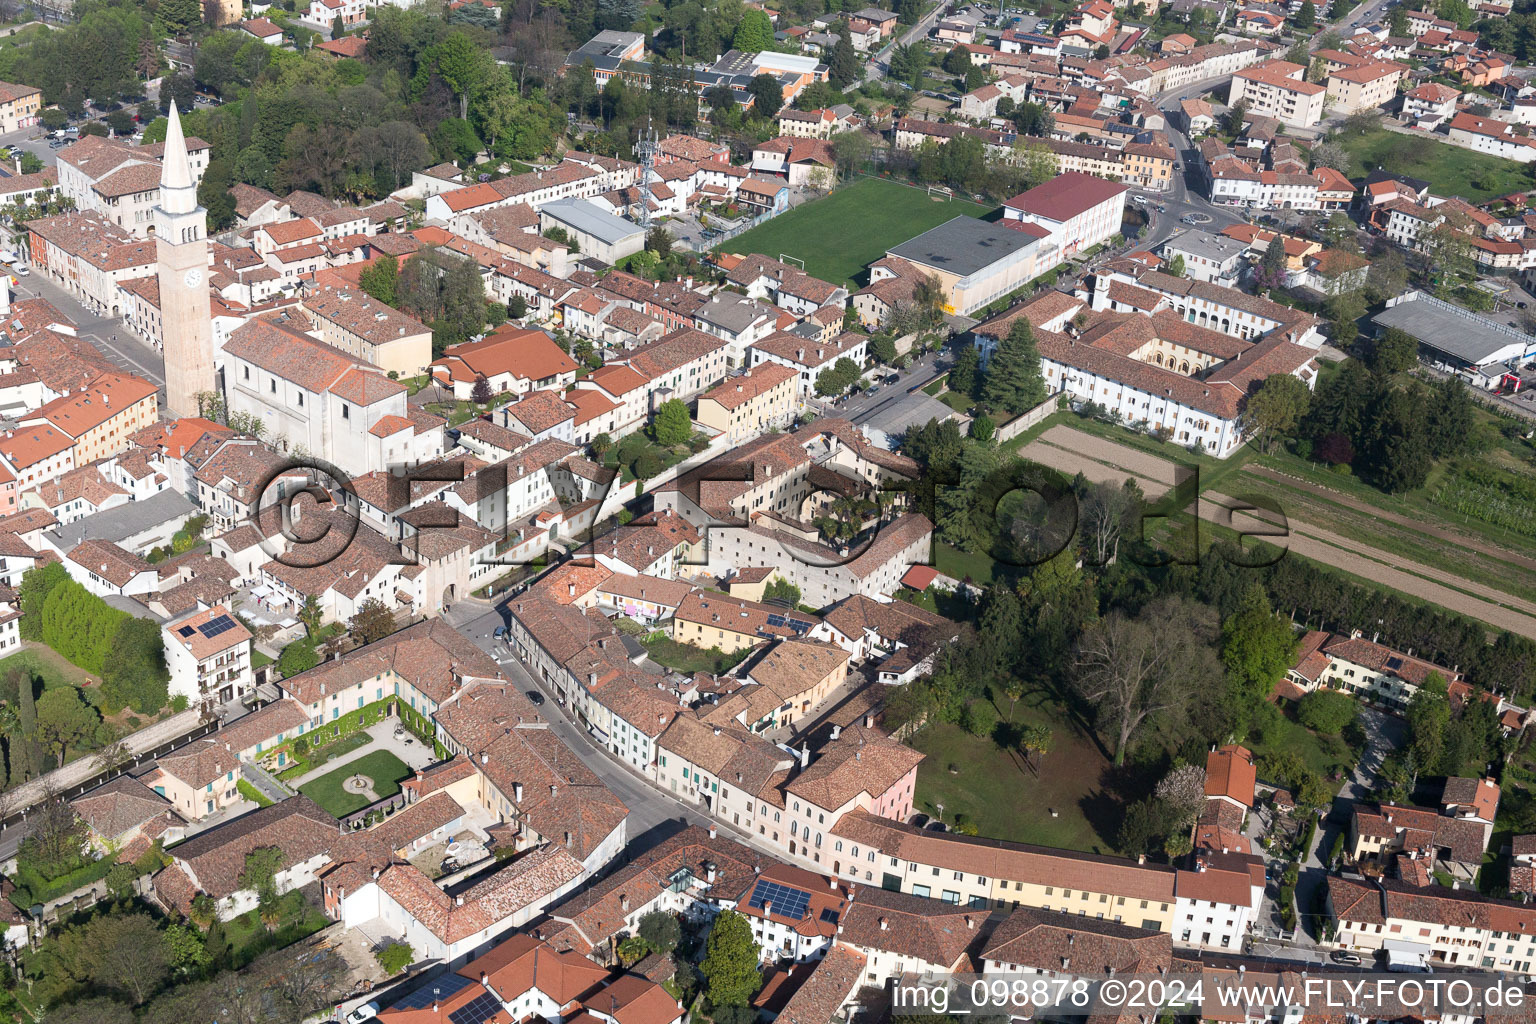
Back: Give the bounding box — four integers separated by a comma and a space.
155, 103, 215, 416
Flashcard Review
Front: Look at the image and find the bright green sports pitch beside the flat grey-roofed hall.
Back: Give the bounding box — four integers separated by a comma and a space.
716, 178, 991, 284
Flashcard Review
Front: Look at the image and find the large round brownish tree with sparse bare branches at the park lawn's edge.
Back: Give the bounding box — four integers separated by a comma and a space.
1074, 597, 1221, 765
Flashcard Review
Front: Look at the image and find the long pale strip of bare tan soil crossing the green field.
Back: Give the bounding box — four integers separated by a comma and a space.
1020, 424, 1536, 636
